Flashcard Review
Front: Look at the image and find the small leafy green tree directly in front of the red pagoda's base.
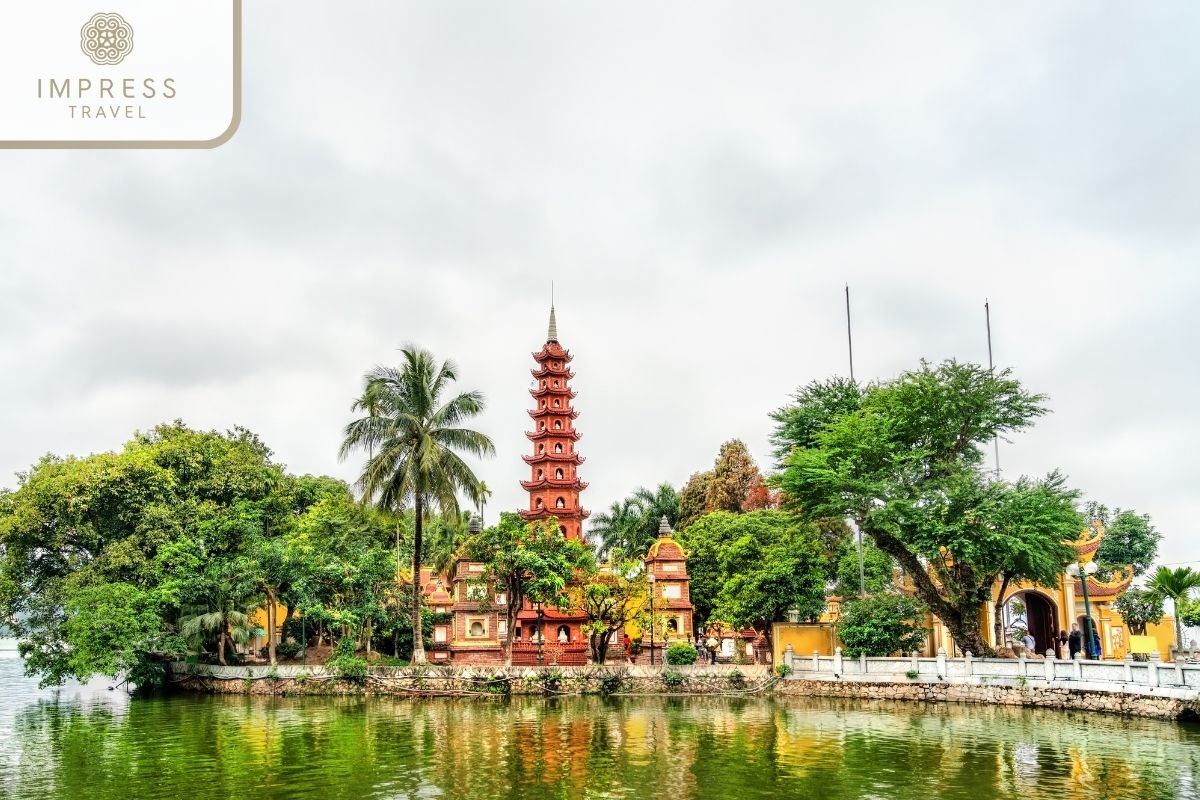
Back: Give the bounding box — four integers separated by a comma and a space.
463, 511, 594, 666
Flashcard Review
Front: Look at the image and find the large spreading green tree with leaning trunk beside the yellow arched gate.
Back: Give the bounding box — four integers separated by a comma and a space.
779, 361, 1082, 655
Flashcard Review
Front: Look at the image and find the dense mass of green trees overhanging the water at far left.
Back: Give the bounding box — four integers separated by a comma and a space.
0, 422, 427, 684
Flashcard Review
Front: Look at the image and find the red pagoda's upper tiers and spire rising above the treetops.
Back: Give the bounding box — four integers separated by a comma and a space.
521, 306, 590, 541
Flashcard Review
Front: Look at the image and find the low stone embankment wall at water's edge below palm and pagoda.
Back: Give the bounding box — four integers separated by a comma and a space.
169, 663, 779, 697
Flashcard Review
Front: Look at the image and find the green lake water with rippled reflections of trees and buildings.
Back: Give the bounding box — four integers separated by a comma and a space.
0, 657, 1200, 800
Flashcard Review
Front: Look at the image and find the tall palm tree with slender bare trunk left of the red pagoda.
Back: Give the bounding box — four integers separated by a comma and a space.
338, 345, 496, 663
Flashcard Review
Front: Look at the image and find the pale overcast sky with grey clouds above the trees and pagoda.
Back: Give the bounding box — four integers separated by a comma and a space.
0, 0, 1200, 563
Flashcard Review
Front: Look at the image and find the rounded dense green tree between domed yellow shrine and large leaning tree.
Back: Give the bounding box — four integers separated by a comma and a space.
715, 511, 826, 631
